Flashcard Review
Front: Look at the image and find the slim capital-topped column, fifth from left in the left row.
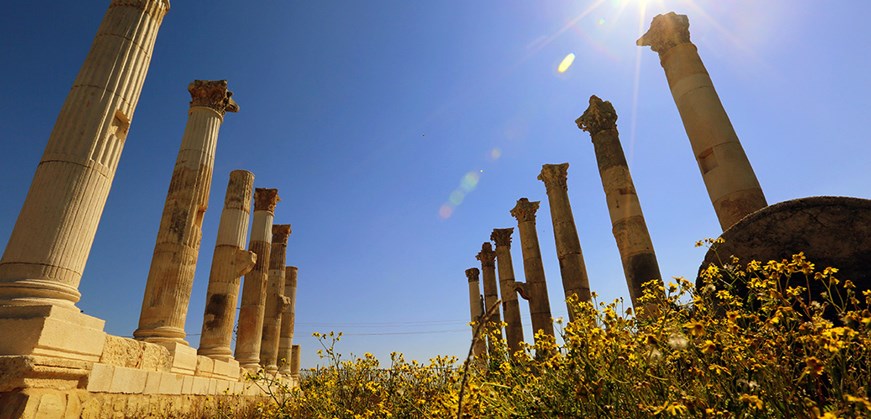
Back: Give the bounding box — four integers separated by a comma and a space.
260, 224, 290, 375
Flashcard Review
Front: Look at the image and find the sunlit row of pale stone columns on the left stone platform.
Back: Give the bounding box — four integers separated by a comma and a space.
0, 0, 299, 388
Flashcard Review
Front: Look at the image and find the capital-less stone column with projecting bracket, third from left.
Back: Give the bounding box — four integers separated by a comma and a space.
197, 170, 257, 361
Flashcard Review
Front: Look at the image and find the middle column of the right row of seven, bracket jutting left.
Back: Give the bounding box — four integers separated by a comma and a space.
511, 198, 556, 336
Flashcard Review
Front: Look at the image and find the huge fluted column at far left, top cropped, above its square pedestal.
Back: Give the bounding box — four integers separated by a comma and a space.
0, 0, 169, 308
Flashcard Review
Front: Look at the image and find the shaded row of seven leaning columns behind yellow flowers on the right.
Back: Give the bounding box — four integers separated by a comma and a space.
466, 13, 767, 356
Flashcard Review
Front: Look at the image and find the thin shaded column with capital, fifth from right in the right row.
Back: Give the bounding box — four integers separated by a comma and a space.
490, 228, 523, 354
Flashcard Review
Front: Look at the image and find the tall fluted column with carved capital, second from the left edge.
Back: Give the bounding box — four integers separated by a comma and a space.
133, 80, 239, 345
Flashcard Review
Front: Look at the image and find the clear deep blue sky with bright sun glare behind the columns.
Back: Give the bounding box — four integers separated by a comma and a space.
0, 0, 871, 367
